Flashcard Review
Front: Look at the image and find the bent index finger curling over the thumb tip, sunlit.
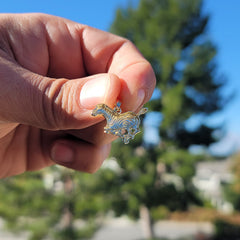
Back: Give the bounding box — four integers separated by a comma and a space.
79, 26, 156, 111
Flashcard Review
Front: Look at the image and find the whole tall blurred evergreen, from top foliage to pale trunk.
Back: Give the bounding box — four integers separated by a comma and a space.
105, 0, 223, 238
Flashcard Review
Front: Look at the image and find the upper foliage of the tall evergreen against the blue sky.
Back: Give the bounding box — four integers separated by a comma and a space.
111, 0, 224, 148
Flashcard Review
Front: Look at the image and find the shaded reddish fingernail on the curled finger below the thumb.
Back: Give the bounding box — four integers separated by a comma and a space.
51, 142, 74, 164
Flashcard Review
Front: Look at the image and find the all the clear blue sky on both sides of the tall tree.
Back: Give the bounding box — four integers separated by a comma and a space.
0, 0, 240, 155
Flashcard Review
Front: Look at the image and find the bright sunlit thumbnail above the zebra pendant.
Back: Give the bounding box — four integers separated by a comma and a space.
80, 75, 109, 109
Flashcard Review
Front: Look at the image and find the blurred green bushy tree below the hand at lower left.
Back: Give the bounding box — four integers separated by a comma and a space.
0, 167, 108, 240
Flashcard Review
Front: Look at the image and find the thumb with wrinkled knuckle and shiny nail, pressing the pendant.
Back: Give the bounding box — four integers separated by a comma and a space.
0, 58, 121, 130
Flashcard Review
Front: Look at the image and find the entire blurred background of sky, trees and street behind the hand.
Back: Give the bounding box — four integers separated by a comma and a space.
0, 0, 240, 240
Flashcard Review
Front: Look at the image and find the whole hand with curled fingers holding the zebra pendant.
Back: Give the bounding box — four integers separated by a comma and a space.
0, 14, 155, 178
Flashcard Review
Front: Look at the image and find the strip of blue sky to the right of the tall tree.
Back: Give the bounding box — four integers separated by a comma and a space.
205, 0, 240, 153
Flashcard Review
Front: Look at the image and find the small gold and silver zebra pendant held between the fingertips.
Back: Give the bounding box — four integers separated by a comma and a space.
92, 102, 147, 144
